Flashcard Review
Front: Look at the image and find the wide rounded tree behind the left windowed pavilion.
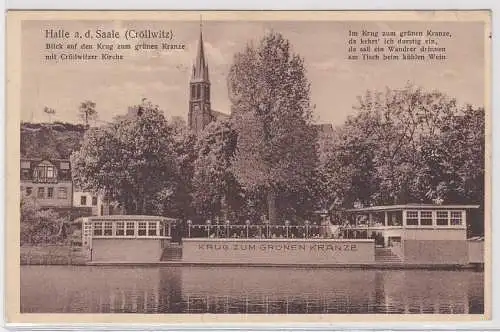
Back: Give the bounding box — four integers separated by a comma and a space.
71, 101, 180, 214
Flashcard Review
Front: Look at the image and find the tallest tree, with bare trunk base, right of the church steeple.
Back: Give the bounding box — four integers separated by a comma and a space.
228, 32, 317, 223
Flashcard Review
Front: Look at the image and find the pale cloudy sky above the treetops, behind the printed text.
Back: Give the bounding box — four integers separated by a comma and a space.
21, 21, 485, 125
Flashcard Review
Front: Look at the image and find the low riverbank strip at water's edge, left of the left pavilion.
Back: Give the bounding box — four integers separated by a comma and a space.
20, 245, 87, 265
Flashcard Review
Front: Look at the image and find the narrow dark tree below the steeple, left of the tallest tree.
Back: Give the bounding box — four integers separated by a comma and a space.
193, 121, 243, 219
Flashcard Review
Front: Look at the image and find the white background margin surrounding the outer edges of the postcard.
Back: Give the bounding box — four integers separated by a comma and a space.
0, 0, 500, 331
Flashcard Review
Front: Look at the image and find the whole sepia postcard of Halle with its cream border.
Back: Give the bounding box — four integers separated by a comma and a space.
1, 11, 491, 321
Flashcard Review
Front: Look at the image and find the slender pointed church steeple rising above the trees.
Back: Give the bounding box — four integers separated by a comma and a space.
188, 21, 212, 135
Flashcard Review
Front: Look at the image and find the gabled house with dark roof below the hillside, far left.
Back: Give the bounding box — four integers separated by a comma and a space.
20, 158, 73, 208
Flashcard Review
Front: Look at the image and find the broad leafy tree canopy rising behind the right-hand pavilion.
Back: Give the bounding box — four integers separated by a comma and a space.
321, 85, 484, 211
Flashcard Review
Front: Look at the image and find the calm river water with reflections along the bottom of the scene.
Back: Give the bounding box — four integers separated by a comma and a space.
21, 266, 484, 314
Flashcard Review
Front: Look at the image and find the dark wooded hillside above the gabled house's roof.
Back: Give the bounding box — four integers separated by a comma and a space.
21, 122, 85, 159
